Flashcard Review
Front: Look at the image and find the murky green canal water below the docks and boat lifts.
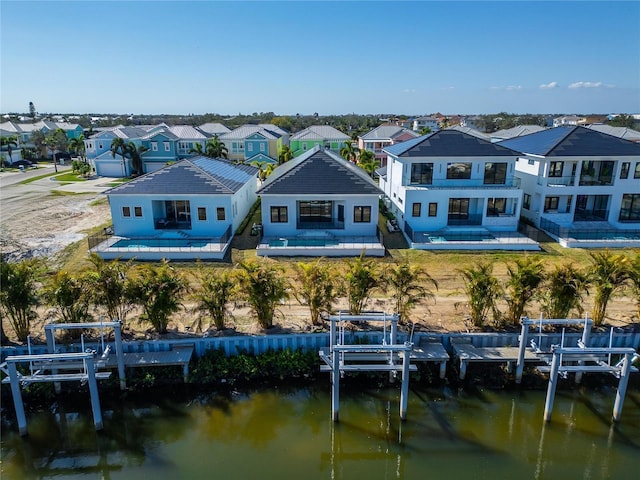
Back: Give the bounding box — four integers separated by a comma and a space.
0, 381, 640, 480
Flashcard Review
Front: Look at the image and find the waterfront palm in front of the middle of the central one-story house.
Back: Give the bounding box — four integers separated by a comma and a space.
294, 259, 339, 325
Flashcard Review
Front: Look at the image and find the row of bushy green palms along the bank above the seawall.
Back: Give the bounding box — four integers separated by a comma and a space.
0, 251, 640, 342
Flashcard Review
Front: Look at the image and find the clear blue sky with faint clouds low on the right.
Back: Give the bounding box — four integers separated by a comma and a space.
0, 0, 640, 115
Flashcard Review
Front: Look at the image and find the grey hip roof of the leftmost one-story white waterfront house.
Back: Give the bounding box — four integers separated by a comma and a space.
105, 156, 258, 195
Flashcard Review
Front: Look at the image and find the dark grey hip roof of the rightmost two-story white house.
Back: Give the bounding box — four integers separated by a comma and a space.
498, 126, 640, 157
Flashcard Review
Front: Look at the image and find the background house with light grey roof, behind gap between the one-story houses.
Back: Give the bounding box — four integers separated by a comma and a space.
220, 124, 288, 163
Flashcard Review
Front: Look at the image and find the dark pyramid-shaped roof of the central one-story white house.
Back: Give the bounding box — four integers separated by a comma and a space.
258, 147, 382, 195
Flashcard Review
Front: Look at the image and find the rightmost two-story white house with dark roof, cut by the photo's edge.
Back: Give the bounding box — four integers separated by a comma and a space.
496, 126, 640, 247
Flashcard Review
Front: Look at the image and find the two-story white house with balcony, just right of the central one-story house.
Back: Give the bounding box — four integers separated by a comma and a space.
378, 129, 539, 250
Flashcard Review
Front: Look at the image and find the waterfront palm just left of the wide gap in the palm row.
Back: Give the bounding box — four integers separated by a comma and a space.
384, 259, 438, 322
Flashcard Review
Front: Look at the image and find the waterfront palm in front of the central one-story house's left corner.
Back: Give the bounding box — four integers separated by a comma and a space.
238, 260, 289, 329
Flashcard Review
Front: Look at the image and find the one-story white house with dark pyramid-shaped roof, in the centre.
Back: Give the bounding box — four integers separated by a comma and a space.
257, 145, 385, 256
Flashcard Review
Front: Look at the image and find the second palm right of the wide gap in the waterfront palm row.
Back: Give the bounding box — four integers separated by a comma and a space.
505, 257, 545, 325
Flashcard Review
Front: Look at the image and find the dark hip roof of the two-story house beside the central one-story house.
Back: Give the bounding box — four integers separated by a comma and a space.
384, 129, 517, 158
